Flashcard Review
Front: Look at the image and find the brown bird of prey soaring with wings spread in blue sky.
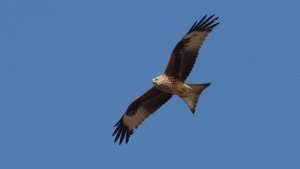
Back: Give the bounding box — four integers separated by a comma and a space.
113, 15, 219, 144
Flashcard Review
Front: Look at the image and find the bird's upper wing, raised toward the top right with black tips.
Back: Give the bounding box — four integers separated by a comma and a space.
165, 15, 219, 81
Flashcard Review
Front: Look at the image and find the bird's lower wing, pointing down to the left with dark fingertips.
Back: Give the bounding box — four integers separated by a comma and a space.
113, 87, 172, 144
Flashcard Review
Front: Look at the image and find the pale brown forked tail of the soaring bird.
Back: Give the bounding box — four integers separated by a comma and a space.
181, 83, 210, 113
